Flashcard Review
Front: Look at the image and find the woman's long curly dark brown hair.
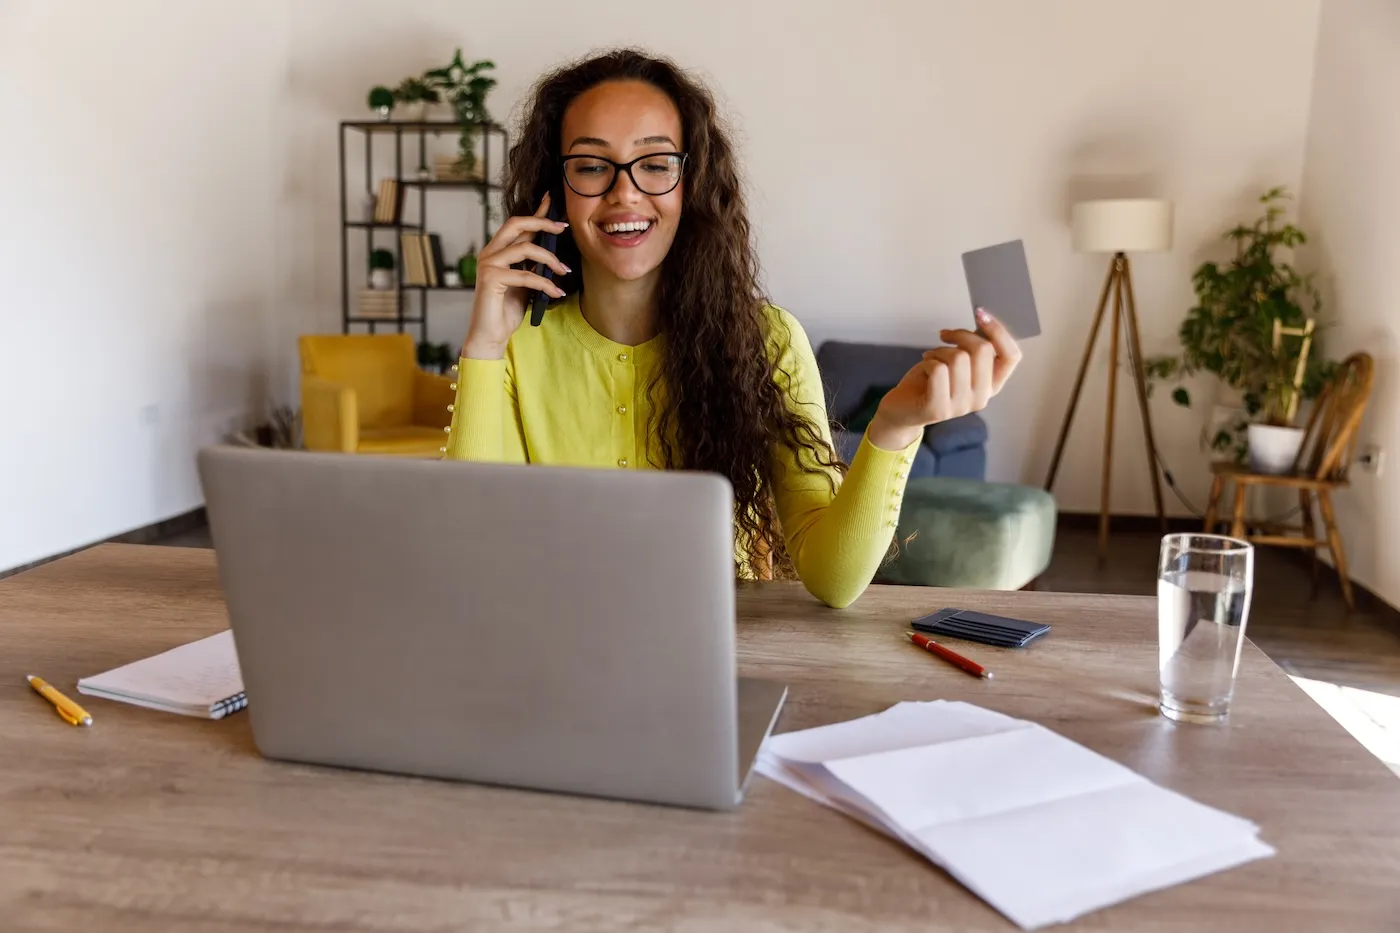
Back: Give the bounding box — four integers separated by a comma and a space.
504, 49, 846, 577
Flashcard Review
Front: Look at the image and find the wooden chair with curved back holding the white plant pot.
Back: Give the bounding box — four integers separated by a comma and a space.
1205, 353, 1375, 609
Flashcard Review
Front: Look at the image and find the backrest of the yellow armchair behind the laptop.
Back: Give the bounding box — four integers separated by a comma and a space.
297, 333, 417, 429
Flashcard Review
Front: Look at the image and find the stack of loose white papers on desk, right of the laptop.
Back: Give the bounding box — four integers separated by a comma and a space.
757, 700, 1274, 930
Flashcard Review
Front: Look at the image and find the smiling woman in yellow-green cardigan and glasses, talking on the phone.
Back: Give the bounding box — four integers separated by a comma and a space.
444, 50, 1021, 607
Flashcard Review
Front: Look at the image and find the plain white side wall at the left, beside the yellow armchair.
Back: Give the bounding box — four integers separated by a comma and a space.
0, 0, 286, 570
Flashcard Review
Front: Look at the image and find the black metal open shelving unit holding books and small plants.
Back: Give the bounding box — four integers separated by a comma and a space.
340, 120, 508, 332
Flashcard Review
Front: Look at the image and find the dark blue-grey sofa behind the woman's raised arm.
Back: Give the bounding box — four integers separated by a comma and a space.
816, 340, 987, 479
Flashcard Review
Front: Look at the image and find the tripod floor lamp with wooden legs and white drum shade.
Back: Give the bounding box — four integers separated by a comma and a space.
1046, 199, 1172, 560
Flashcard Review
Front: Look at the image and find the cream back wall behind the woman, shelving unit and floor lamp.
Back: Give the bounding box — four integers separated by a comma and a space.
281, 0, 1317, 513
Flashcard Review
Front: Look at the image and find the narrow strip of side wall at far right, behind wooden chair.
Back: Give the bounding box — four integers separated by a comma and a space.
1301, 0, 1400, 605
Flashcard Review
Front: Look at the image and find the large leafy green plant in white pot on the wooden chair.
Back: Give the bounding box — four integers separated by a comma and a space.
1145, 188, 1334, 472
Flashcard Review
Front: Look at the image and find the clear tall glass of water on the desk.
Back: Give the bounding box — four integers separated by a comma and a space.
1156, 534, 1254, 723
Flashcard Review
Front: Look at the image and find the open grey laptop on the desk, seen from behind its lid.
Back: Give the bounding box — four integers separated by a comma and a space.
199, 447, 787, 810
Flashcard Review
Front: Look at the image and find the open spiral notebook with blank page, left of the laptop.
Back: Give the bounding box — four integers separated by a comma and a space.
78, 630, 248, 719
